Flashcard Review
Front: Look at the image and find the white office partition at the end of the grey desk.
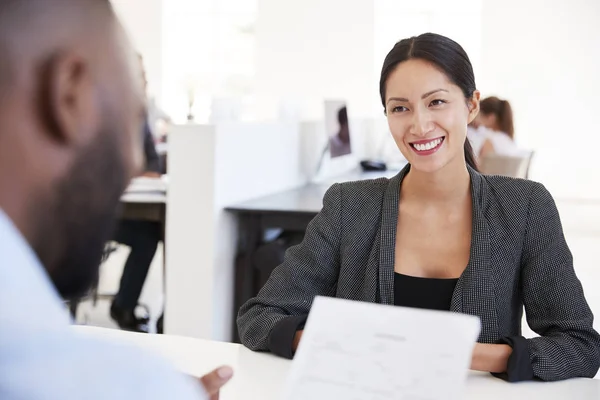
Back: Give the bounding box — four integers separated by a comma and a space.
165, 123, 306, 341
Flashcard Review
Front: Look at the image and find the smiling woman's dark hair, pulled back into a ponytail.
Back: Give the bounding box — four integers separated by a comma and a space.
379, 33, 477, 170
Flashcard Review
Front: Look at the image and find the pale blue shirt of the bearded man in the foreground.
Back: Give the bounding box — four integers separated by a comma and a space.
0, 209, 205, 400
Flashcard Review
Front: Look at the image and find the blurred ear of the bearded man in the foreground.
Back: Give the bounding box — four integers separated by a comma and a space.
40, 54, 98, 144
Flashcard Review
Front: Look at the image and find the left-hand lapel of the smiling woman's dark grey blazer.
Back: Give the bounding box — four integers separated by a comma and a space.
378, 164, 410, 305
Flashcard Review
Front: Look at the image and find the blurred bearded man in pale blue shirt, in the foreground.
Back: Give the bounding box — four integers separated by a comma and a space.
0, 0, 233, 400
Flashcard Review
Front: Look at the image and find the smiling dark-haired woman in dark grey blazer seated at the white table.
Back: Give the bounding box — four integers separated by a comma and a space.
238, 33, 600, 381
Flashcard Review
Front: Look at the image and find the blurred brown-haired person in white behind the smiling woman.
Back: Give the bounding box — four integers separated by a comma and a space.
468, 96, 521, 157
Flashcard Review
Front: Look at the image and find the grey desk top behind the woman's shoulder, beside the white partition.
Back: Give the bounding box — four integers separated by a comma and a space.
227, 170, 399, 214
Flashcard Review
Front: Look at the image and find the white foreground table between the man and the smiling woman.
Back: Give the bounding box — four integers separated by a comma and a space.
74, 327, 600, 400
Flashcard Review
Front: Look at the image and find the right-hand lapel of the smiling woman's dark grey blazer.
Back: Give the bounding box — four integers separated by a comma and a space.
451, 168, 499, 343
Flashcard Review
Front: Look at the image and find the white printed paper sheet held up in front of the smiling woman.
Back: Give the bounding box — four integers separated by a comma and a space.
284, 297, 480, 400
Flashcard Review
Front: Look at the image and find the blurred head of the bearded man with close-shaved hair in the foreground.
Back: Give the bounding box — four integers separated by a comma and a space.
0, 0, 144, 295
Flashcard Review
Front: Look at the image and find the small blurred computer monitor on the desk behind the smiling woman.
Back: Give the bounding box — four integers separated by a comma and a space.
325, 100, 352, 158
